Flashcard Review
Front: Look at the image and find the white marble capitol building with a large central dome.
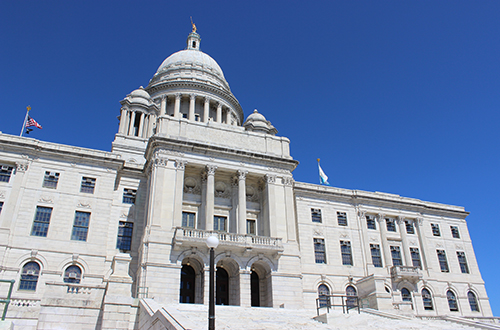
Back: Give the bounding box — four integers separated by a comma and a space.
0, 29, 492, 329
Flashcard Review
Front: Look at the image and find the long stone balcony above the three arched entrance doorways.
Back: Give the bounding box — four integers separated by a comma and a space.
173, 227, 284, 254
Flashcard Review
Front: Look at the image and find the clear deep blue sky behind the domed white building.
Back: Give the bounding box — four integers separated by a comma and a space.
0, 0, 500, 315
